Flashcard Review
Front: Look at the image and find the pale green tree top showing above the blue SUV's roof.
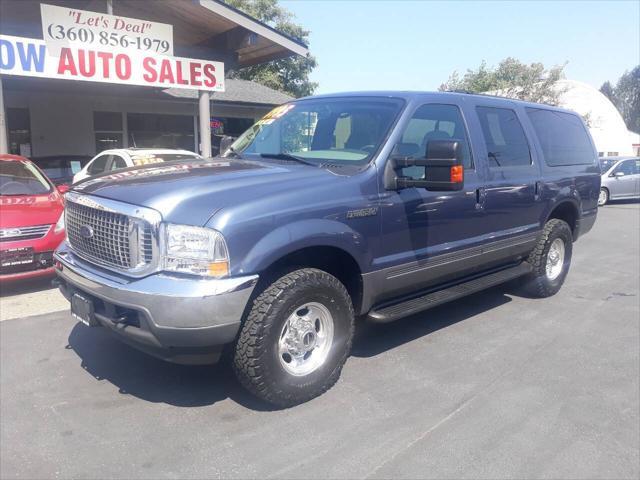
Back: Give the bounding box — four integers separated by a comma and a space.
439, 57, 566, 105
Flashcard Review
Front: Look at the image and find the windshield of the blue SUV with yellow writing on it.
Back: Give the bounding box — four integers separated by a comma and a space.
225, 97, 403, 165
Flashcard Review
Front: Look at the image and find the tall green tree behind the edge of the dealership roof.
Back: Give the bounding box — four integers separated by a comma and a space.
226, 0, 318, 97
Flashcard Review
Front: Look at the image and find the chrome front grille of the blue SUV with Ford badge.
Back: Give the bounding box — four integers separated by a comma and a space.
65, 198, 154, 273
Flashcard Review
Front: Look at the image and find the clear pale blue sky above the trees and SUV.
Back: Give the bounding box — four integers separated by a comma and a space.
280, 0, 640, 93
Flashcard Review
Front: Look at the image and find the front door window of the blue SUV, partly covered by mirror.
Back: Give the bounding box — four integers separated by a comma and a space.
396, 104, 473, 180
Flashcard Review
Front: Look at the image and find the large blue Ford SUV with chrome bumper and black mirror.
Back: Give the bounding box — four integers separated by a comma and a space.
55, 92, 600, 407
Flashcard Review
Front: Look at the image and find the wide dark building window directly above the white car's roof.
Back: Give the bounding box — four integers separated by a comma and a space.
127, 113, 194, 150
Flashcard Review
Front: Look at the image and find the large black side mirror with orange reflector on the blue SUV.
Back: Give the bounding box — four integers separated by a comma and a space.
384, 140, 464, 192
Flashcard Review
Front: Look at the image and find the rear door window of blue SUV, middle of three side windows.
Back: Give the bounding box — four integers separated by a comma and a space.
476, 107, 531, 168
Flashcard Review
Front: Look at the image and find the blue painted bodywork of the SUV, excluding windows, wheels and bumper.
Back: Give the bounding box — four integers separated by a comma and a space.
74, 92, 600, 313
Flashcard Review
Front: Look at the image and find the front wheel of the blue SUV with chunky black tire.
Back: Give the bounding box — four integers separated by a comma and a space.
233, 268, 354, 407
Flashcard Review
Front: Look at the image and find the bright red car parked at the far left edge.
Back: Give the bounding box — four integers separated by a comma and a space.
0, 155, 68, 282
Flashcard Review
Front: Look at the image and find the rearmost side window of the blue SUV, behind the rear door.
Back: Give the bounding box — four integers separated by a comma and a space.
526, 108, 596, 167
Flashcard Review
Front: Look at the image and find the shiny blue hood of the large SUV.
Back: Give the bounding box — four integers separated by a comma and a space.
72, 158, 344, 225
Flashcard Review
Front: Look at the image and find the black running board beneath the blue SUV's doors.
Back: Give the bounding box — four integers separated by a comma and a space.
367, 262, 531, 323
